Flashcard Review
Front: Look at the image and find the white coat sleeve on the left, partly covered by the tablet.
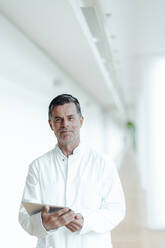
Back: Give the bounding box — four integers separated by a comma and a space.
19, 162, 56, 238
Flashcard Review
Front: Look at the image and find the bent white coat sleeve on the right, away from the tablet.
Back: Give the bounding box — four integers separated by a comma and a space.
80, 161, 125, 234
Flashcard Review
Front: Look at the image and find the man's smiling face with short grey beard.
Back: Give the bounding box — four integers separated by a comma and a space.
49, 103, 83, 145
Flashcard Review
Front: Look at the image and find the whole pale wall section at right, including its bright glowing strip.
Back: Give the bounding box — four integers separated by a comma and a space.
138, 56, 165, 229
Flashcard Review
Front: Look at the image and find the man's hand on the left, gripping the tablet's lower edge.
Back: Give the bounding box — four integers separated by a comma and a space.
41, 206, 76, 231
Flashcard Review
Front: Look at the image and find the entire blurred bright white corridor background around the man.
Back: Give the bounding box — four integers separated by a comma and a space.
0, 0, 165, 248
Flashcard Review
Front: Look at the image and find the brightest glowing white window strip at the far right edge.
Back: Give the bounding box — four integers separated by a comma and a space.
148, 58, 165, 228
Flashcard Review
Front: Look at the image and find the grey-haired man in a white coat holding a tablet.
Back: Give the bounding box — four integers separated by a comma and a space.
19, 94, 125, 248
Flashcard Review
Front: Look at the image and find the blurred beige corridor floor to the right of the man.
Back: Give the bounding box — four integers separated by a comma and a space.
112, 151, 165, 248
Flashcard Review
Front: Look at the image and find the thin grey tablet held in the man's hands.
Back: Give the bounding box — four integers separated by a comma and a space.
22, 201, 65, 216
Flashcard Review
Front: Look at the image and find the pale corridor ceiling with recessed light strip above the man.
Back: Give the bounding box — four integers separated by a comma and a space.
0, 0, 165, 121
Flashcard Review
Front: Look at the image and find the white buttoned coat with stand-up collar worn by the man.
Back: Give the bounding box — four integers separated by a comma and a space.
19, 144, 125, 248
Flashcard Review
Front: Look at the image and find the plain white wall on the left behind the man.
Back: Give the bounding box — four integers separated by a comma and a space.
0, 12, 124, 248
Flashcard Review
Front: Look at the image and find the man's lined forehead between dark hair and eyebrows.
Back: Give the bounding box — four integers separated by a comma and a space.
52, 102, 77, 116
